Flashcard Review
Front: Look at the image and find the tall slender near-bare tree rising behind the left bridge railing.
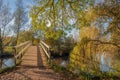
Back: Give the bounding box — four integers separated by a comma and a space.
14, 0, 27, 45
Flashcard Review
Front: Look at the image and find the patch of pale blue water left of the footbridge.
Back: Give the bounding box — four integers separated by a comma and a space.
2, 58, 15, 69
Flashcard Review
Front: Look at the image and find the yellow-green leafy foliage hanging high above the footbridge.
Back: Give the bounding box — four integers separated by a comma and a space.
30, 0, 78, 44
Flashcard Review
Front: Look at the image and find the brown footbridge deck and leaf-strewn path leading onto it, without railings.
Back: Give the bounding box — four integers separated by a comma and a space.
0, 46, 61, 80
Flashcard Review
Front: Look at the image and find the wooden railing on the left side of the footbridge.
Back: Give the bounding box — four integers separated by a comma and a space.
13, 41, 32, 64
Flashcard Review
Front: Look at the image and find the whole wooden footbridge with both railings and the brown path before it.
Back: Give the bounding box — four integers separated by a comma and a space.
0, 41, 61, 80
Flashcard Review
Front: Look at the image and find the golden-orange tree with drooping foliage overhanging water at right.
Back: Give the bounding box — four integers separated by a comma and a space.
70, 0, 120, 75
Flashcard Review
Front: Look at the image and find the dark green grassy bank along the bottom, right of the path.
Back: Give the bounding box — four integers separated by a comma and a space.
51, 58, 120, 80
